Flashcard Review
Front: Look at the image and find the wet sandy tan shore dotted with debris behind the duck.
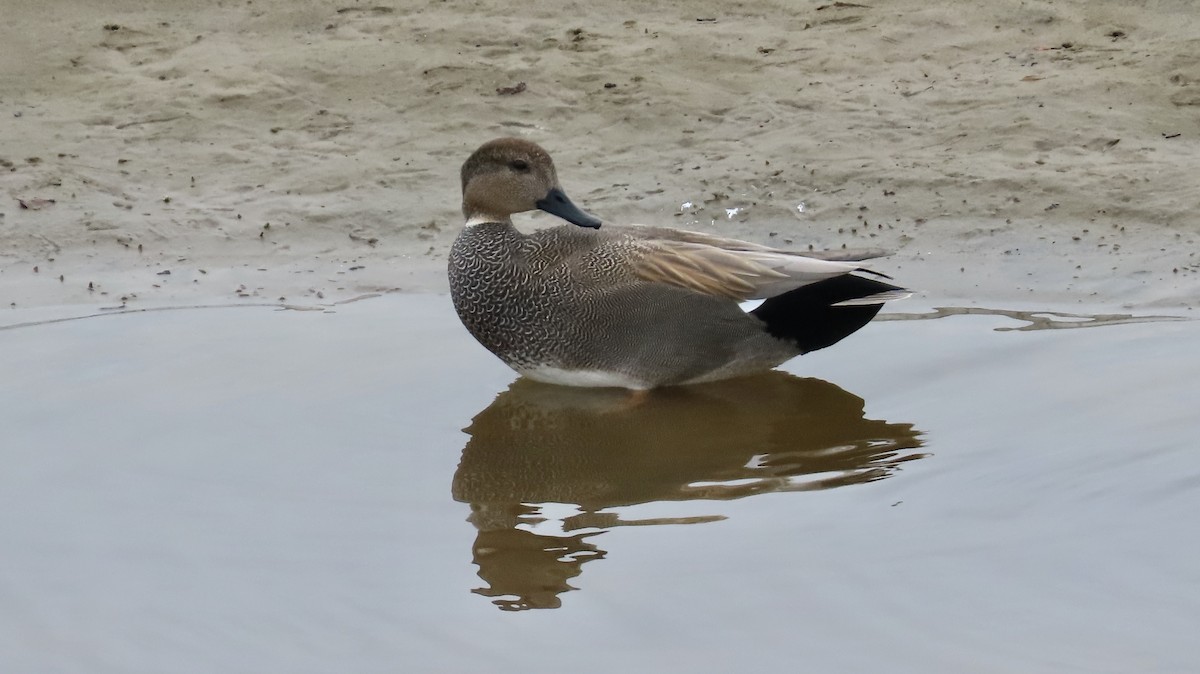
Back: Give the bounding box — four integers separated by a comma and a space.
0, 0, 1200, 311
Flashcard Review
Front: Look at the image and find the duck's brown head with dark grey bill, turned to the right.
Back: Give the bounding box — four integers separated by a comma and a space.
462, 138, 600, 229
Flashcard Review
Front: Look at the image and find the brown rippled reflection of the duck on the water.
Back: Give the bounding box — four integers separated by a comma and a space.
452, 371, 925, 610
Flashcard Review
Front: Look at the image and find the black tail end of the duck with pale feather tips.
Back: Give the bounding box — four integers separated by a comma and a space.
750, 273, 912, 354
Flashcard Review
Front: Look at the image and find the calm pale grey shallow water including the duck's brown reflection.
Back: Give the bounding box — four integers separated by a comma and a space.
0, 295, 1200, 673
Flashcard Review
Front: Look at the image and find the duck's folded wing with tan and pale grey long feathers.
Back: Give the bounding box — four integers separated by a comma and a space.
613, 227, 865, 301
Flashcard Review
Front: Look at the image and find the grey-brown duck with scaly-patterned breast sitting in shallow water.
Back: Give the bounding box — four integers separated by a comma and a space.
448, 138, 911, 391
